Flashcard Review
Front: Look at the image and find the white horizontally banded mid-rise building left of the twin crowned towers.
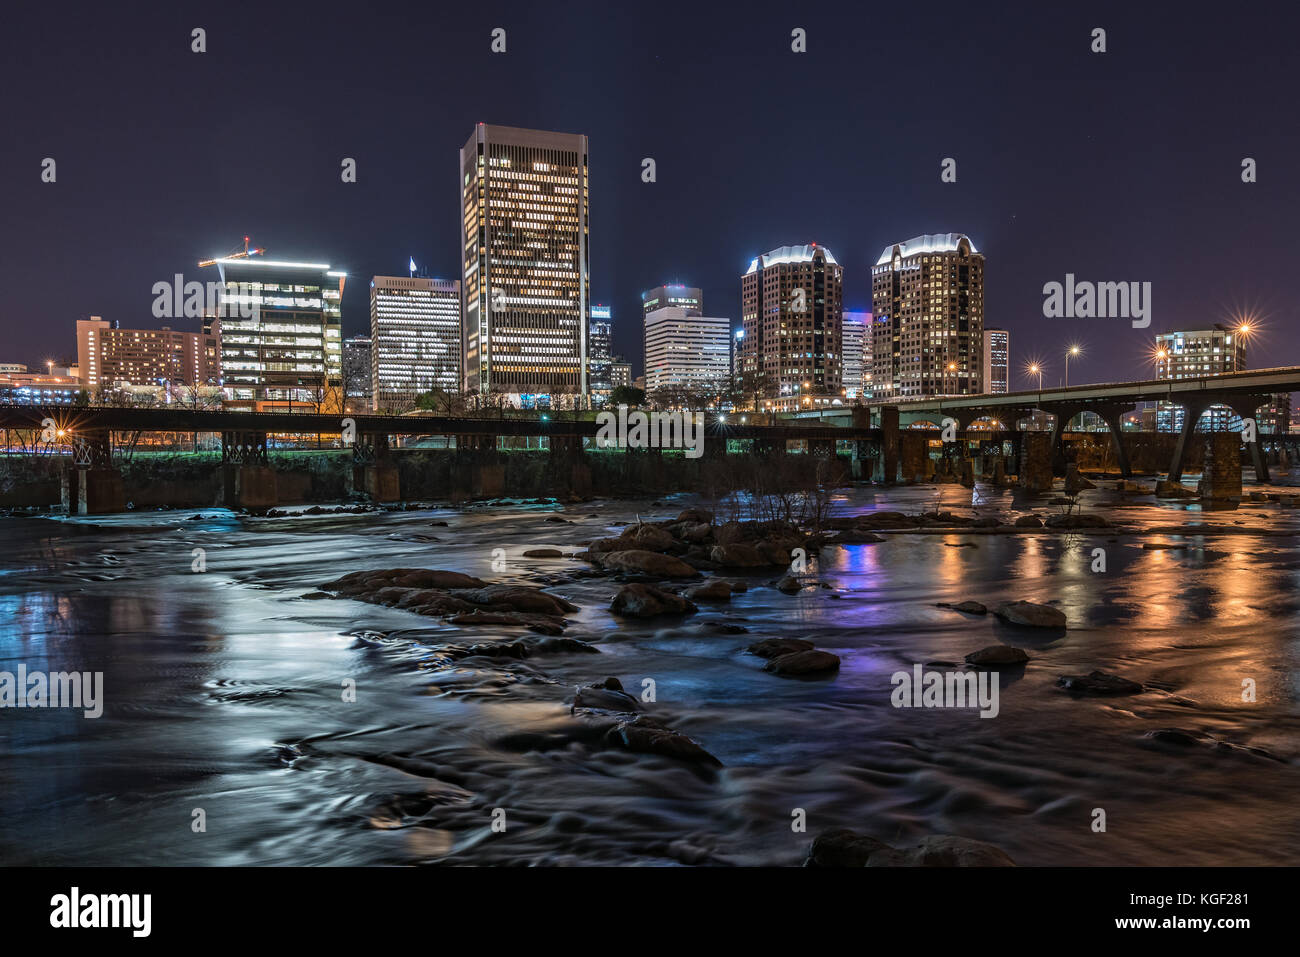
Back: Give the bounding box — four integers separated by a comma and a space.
645, 306, 731, 393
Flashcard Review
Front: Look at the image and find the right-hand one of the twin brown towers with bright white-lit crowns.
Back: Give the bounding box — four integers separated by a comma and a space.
871, 233, 984, 399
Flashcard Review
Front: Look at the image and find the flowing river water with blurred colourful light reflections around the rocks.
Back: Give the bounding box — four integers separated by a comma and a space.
0, 486, 1300, 865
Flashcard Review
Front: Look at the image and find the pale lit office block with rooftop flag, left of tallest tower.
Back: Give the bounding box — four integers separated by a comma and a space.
371, 276, 460, 408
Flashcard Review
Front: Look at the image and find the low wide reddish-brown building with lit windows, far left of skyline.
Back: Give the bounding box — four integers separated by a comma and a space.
77, 316, 221, 390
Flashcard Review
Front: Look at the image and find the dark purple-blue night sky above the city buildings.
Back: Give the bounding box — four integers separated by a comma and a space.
0, 0, 1300, 387
